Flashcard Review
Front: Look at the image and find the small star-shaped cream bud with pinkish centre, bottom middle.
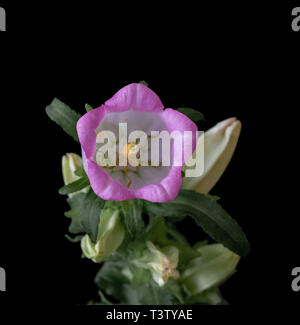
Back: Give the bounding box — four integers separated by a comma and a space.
138, 241, 179, 286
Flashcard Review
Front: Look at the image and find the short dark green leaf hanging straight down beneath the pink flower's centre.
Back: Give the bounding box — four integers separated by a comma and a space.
122, 199, 144, 237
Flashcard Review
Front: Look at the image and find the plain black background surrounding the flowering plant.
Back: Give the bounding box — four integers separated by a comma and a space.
0, 1, 300, 318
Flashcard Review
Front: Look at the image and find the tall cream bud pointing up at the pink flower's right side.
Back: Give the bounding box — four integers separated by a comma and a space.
182, 117, 242, 194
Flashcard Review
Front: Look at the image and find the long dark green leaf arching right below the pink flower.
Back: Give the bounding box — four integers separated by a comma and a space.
144, 190, 250, 256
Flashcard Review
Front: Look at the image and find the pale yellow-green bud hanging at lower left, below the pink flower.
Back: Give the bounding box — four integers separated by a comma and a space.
81, 208, 125, 263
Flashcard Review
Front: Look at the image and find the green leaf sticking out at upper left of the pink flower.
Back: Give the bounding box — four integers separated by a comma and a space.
46, 98, 81, 142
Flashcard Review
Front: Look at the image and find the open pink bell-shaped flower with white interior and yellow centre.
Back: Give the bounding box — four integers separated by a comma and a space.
77, 83, 197, 202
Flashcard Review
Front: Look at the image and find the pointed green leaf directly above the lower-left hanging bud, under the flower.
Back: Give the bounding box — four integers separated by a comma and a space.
80, 188, 105, 243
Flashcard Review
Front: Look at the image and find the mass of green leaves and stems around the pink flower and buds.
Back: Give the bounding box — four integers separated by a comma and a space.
46, 86, 249, 305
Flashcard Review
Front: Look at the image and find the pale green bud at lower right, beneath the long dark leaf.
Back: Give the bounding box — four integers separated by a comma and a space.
180, 244, 240, 295
